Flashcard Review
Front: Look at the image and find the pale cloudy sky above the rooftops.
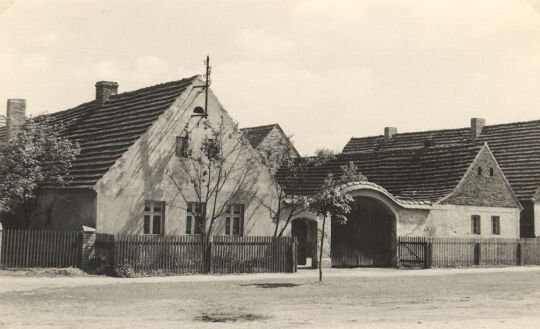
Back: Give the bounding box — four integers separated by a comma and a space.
0, 0, 540, 155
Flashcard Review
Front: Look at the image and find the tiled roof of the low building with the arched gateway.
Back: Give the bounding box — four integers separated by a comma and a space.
276, 144, 481, 203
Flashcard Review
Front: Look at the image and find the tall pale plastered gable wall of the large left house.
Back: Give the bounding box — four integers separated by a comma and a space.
96, 81, 275, 235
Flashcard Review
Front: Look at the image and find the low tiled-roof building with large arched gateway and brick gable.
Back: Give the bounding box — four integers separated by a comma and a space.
276, 143, 521, 266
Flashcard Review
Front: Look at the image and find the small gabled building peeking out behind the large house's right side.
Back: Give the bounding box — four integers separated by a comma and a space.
240, 123, 300, 158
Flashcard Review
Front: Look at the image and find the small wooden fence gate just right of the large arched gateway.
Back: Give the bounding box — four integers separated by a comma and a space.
397, 237, 431, 268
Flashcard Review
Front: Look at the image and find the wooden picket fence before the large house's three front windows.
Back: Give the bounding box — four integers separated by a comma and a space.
95, 234, 297, 274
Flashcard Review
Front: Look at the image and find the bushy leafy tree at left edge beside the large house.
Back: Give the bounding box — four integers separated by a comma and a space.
0, 116, 79, 227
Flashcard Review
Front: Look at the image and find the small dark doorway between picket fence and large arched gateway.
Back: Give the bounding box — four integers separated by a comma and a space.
291, 218, 317, 268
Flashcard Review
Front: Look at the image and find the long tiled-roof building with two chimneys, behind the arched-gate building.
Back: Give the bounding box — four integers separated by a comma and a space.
343, 118, 540, 237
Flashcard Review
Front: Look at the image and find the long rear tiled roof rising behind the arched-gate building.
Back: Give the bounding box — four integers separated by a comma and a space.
343, 120, 540, 201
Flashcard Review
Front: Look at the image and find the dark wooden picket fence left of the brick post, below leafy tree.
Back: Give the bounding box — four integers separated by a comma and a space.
0, 229, 80, 268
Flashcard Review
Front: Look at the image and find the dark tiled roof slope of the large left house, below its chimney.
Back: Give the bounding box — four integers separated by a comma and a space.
44, 77, 195, 188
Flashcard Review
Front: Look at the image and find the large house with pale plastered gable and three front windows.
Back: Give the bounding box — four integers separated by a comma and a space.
2, 76, 282, 235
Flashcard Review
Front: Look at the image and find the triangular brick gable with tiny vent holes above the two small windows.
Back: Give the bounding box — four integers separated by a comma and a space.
440, 147, 519, 208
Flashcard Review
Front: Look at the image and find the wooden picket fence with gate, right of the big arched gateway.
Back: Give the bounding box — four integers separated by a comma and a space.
397, 237, 540, 268
